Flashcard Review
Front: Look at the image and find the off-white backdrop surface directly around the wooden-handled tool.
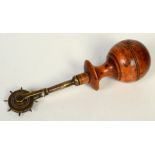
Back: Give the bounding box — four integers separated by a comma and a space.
0, 33, 155, 121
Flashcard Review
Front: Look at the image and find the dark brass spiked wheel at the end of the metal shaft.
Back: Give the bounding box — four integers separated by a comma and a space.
8, 88, 34, 116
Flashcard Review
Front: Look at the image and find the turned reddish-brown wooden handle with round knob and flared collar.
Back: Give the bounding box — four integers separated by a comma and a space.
79, 40, 151, 90
